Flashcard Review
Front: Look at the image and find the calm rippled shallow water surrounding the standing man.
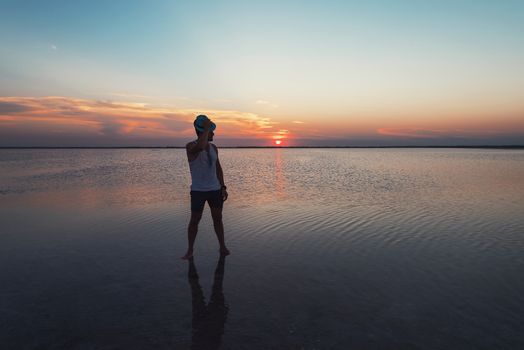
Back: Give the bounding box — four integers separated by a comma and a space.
0, 149, 524, 349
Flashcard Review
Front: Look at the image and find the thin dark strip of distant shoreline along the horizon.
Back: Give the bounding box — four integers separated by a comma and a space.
0, 145, 524, 149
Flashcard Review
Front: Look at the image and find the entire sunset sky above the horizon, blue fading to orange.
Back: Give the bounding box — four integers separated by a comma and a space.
0, 0, 524, 146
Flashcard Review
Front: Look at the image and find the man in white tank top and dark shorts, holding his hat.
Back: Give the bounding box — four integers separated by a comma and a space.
182, 115, 230, 260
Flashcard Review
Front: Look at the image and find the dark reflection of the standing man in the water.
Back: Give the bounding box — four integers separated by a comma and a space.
187, 255, 229, 349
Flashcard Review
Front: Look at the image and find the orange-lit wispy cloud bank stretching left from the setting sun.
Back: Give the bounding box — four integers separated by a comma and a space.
0, 96, 274, 145
